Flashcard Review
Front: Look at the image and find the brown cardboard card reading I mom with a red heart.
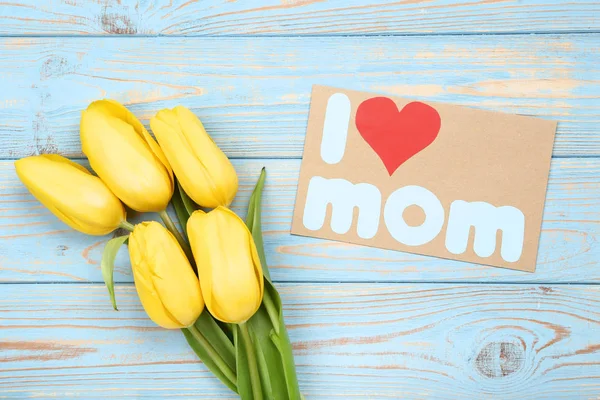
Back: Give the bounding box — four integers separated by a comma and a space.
292, 86, 556, 272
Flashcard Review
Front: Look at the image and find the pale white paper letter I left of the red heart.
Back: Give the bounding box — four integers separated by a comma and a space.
321, 93, 352, 164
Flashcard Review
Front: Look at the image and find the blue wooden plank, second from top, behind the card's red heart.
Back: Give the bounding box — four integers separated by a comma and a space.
0, 35, 600, 159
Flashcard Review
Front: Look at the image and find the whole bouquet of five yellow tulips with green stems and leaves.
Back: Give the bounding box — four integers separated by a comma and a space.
15, 100, 302, 400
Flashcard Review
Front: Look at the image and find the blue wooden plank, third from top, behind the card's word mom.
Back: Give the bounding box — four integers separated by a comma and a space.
0, 159, 600, 282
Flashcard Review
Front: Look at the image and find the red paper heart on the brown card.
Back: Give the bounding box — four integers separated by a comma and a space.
356, 97, 441, 176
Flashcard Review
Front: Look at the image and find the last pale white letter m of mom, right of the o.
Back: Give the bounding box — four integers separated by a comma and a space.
446, 200, 525, 262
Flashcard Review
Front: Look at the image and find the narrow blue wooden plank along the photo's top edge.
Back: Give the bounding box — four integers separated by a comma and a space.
0, 0, 600, 35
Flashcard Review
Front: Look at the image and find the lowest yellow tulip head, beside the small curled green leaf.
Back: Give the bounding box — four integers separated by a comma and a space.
129, 221, 204, 329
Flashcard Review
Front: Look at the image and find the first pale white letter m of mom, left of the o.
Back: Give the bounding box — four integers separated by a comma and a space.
302, 176, 381, 239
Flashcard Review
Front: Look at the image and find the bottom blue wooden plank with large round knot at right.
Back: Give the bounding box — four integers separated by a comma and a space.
0, 284, 600, 400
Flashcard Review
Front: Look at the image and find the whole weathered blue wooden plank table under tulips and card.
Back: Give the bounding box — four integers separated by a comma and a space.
0, 0, 600, 399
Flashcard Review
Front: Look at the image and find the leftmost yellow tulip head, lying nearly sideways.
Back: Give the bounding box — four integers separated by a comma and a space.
15, 154, 125, 235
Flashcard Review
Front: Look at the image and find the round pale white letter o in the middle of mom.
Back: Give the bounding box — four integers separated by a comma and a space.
383, 185, 445, 246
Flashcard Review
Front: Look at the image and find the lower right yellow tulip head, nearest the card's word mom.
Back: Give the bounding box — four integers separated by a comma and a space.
187, 207, 263, 324
